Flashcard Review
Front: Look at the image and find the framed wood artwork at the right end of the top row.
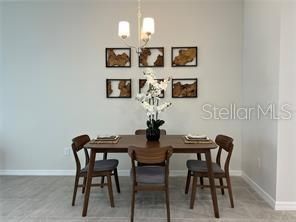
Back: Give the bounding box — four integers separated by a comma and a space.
172, 47, 197, 67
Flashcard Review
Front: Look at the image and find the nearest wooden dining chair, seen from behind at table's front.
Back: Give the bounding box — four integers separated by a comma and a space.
128, 146, 172, 222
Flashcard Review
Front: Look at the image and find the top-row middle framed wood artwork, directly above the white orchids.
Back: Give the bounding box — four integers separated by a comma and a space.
139, 47, 164, 67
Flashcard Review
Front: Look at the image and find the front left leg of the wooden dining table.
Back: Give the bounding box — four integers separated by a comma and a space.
82, 149, 96, 217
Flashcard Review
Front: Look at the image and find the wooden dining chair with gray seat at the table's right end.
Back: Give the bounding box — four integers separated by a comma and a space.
185, 135, 234, 209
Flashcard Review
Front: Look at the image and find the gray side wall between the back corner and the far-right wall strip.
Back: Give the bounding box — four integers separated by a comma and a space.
242, 1, 280, 199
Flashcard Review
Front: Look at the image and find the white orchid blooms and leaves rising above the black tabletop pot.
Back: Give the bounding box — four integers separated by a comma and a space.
136, 68, 172, 129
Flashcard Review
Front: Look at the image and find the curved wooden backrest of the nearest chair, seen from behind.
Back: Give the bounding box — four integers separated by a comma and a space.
128, 146, 173, 185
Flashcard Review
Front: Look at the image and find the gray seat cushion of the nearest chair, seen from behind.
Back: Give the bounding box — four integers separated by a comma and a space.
131, 166, 165, 184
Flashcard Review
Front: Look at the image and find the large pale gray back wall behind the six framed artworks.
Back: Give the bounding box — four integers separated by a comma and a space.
0, 0, 242, 170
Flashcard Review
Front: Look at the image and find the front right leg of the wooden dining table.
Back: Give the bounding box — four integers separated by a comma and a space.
206, 150, 219, 218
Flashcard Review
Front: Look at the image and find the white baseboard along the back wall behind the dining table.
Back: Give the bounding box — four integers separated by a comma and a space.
0, 170, 242, 177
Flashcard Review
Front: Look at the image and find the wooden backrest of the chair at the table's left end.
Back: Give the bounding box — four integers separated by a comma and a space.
72, 135, 90, 171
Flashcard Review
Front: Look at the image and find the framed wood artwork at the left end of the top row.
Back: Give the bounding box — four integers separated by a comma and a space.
105, 48, 131, 68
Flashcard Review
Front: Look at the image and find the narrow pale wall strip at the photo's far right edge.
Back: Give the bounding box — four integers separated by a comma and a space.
276, 1, 296, 204
